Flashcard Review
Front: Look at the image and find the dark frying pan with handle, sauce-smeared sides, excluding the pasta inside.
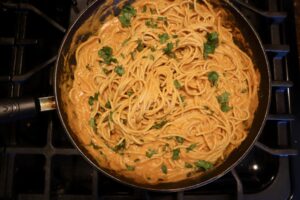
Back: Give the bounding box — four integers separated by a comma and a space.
0, 0, 271, 191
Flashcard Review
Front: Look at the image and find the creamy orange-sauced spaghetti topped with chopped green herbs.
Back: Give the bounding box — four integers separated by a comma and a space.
68, 0, 260, 184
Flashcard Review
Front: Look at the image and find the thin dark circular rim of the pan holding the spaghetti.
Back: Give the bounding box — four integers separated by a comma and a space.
53, 0, 271, 192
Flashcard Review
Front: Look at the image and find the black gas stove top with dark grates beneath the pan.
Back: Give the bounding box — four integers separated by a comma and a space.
0, 0, 300, 200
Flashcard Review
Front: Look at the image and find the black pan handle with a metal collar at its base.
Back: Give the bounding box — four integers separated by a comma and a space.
0, 96, 56, 122
